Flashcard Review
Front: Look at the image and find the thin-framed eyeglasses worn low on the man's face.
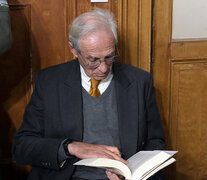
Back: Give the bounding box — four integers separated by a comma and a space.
78, 46, 119, 69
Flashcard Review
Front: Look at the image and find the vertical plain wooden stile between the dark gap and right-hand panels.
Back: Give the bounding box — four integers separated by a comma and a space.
152, 0, 172, 129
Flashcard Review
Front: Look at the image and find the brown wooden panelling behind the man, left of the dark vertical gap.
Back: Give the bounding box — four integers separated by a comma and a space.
0, 0, 151, 180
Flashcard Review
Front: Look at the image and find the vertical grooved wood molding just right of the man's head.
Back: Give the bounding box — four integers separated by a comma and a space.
118, 0, 152, 71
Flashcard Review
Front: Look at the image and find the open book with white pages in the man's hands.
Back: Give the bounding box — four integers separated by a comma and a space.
74, 151, 177, 180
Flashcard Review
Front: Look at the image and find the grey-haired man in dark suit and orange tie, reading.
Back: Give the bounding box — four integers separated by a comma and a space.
13, 9, 164, 180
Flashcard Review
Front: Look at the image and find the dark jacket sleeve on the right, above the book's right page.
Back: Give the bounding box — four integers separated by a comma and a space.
143, 75, 165, 150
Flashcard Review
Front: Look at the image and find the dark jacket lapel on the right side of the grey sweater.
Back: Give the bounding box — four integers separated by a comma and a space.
113, 64, 139, 159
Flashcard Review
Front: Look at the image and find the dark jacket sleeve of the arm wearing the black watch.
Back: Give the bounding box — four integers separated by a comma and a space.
13, 71, 63, 170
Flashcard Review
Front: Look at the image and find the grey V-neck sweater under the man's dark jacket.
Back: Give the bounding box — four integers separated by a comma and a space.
74, 80, 120, 180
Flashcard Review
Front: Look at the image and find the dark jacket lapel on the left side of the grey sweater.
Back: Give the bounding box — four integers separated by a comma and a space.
59, 61, 83, 141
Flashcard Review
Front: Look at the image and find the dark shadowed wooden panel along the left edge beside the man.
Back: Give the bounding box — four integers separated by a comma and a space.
0, 4, 32, 179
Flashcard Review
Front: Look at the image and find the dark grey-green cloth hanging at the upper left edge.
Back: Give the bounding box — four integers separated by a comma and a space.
0, 5, 12, 55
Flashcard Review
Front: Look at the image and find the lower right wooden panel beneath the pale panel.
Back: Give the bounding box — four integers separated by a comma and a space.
170, 60, 207, 180
